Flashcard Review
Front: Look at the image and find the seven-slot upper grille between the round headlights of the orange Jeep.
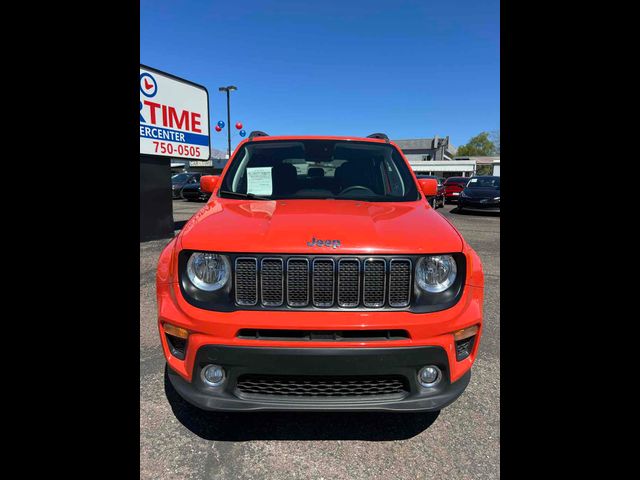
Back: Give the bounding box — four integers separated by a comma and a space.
234, 256, 413, 308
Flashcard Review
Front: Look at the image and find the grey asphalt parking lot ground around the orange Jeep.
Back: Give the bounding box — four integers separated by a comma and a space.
140, 200, 500, 480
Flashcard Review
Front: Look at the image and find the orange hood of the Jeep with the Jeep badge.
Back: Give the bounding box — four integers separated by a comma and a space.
179, 196, 463, 255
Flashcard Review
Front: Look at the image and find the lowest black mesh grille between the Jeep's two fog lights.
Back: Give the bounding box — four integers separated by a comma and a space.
237, 374, 409, 398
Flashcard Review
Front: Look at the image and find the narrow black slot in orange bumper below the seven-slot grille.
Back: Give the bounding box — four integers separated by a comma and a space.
237, 328, 411, 342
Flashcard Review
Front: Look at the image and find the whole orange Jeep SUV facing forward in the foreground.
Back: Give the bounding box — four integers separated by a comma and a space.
157, 132, 484, 411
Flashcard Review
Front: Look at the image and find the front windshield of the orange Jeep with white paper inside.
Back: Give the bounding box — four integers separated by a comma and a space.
220, 140, 420, 202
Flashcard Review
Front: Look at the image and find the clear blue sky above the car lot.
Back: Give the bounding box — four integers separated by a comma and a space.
140, 0, 500, 152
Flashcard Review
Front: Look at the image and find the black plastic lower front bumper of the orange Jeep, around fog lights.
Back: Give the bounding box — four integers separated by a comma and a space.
168, 345, 471, 412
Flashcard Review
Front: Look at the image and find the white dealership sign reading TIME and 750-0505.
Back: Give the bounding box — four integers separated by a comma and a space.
140, 65, 210, 160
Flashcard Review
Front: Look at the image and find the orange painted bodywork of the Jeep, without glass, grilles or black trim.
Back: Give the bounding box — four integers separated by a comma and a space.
156, 136, 484, 394
